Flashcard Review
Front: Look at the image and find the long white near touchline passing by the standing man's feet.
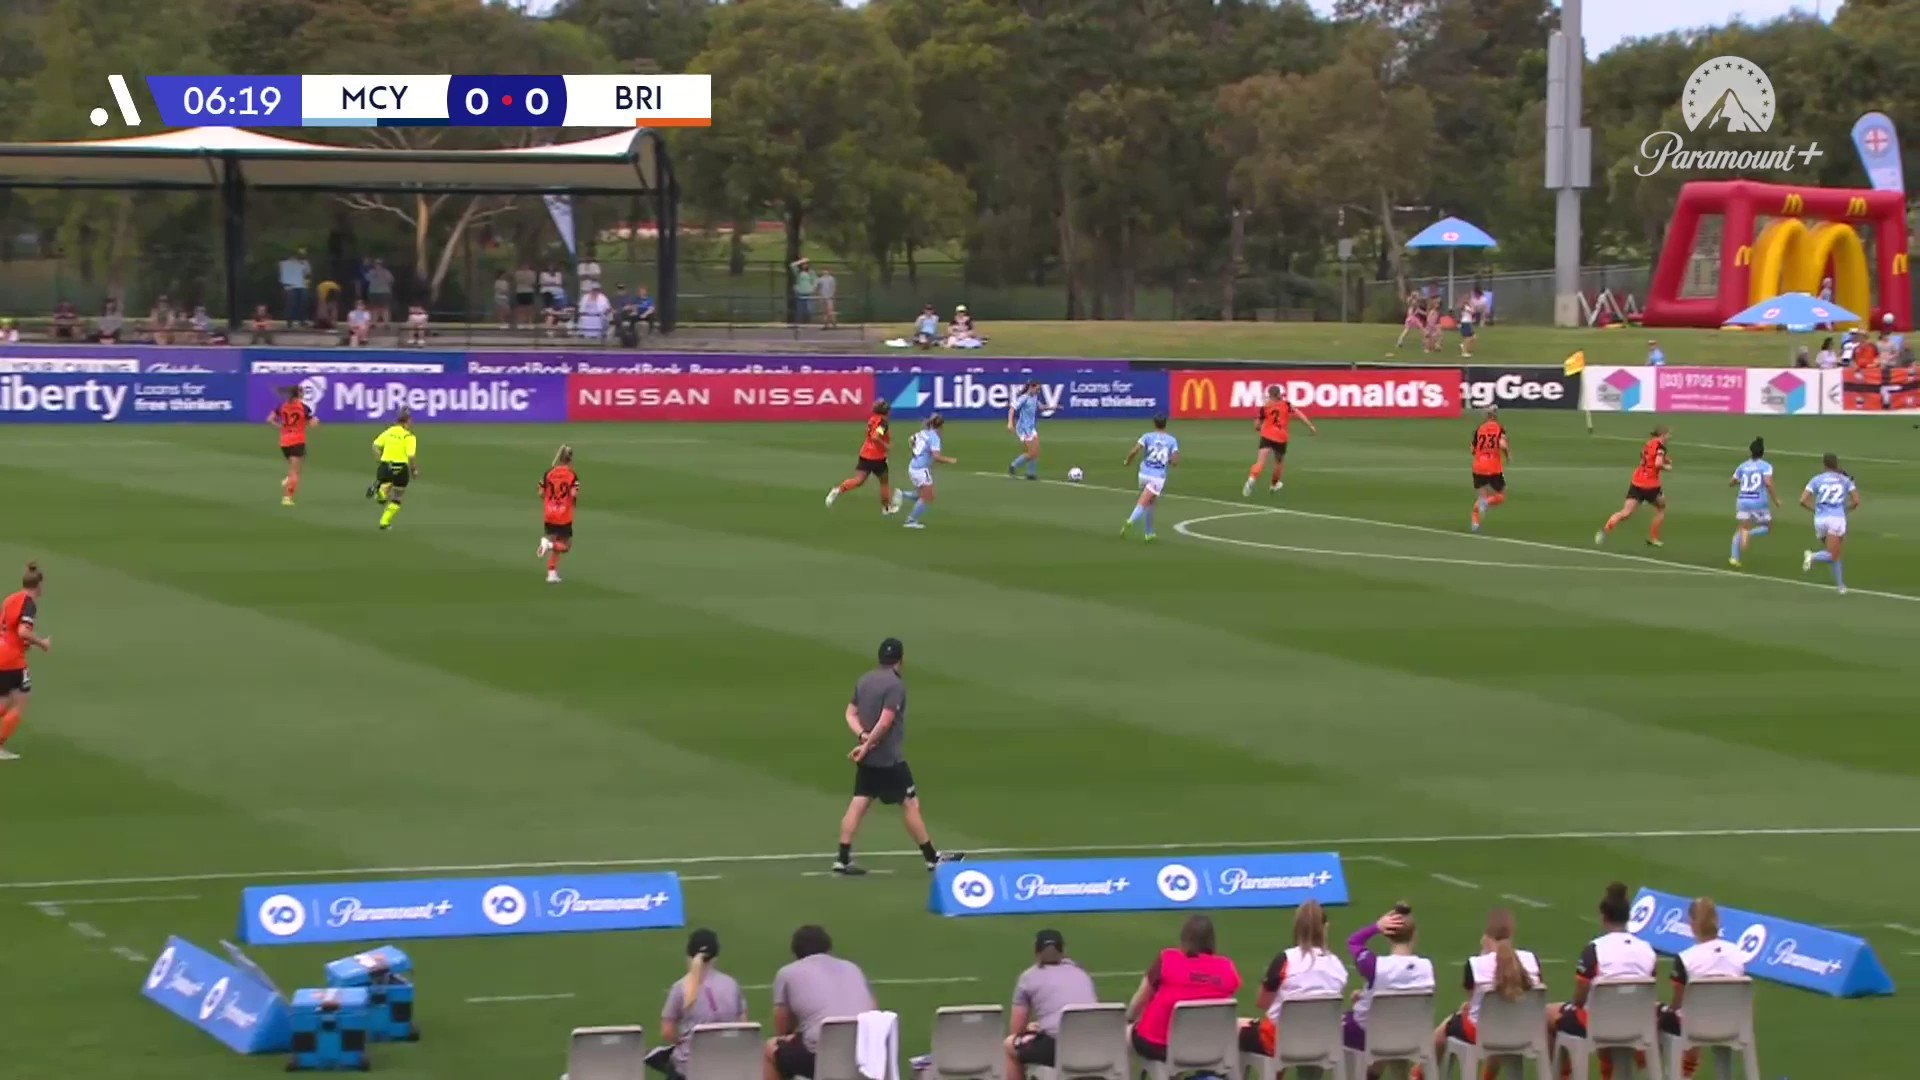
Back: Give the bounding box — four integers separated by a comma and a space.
0, 824, 1920, 891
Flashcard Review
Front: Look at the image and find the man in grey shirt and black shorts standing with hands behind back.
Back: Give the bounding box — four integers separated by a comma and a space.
833, 638, 962, 876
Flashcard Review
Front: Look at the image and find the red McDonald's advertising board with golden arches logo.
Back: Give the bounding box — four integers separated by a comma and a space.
1167, 367, 1465, 419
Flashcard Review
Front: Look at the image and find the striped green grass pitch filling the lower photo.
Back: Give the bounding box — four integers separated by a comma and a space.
0, 411, 1920, 1080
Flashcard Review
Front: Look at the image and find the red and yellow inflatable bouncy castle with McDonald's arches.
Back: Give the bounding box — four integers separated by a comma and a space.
1644, 181, 1912, 331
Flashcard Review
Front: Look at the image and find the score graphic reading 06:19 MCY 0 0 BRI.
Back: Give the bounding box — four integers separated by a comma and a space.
146, 75, 712, 127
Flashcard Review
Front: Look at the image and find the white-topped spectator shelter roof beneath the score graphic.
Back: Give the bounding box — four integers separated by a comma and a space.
0, 127, 672, 196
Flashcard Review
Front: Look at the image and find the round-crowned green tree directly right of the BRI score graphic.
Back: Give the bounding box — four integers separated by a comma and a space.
682, 0, 920, 315
